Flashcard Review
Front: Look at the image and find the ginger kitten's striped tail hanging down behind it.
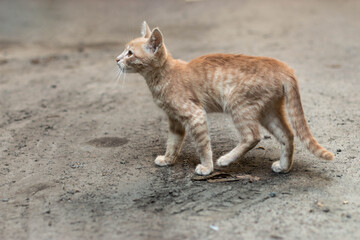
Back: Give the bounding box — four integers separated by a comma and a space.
284, 77, 334, 160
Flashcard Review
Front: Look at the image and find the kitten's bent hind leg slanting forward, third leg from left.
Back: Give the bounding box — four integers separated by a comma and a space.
216, 113, 260, 166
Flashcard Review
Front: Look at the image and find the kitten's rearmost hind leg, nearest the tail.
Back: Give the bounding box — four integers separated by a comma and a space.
262, 104, 294, 173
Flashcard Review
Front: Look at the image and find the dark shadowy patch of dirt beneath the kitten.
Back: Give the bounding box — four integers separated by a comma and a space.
63, 141, 333, 221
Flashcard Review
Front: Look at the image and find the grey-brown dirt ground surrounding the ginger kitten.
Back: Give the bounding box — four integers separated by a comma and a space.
0, 0, 360, 240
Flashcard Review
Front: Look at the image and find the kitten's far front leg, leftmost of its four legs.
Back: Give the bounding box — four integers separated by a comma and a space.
155, 117, 185, 166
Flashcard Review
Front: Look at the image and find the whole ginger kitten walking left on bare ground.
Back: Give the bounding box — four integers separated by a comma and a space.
116, 22, 334, 175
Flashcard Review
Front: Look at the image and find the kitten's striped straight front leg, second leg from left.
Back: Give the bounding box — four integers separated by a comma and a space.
187, 109, 214, 175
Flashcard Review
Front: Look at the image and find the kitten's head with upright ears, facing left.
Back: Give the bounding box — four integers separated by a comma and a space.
116, 21, 168, 73
